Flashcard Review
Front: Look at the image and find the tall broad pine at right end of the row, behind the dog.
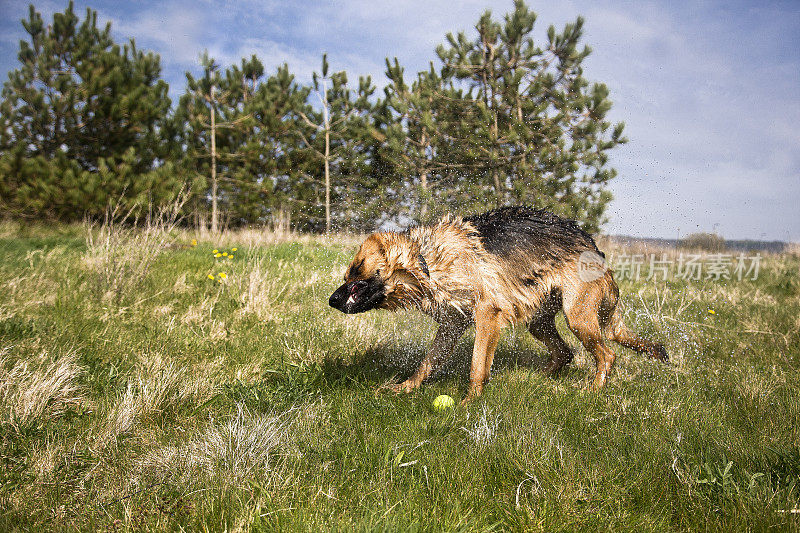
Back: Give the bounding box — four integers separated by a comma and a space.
418, 0, 626, 231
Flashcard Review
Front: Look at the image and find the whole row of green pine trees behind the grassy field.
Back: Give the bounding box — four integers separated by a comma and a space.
0, 0, 626, 231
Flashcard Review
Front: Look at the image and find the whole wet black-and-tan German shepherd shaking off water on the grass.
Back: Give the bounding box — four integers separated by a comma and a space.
329, 207, 667, 402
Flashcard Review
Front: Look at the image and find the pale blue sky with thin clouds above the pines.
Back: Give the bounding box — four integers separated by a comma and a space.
0, 0, 800, 242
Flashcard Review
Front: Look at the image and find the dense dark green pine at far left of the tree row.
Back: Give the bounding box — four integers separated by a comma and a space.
0, 2, 174, 220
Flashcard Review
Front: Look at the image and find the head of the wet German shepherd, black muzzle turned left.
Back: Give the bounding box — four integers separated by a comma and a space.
328, 233, 427, 314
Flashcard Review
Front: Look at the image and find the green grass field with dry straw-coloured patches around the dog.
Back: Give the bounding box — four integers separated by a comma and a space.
0, 219, 800, 531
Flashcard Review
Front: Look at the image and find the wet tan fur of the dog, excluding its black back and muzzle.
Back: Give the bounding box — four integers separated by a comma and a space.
345, 212, 665, 401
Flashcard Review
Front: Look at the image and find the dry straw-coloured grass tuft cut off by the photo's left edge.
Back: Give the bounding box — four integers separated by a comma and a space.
0, 346, 88, 430
